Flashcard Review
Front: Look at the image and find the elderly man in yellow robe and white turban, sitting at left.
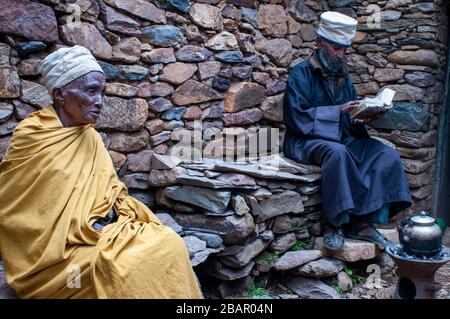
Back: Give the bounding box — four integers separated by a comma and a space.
0, 46, 203, 299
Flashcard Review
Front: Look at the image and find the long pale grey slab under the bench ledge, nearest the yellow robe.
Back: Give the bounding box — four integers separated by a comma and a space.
164, 186, 231, 214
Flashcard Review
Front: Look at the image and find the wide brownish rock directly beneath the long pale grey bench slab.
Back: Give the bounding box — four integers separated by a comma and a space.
174, 214, 255, 245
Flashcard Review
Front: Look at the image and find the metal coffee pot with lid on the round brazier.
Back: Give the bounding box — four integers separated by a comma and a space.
397, 212, 443, 257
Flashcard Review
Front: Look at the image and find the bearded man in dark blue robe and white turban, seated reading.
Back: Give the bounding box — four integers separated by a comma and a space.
283, 12, 411, 250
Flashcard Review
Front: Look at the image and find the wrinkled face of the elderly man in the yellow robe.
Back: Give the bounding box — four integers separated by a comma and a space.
56, 72, 106, 126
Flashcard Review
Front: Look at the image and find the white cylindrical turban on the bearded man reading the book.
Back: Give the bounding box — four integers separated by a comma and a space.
317, 11, 358, 46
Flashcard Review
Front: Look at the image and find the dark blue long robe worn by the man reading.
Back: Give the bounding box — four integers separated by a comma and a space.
283, 55, 411, 221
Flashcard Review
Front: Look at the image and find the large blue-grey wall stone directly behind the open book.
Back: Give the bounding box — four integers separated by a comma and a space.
370, 102, 430, 131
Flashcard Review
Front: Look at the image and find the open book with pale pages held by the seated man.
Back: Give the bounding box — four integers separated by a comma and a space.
350, 88, 395, 119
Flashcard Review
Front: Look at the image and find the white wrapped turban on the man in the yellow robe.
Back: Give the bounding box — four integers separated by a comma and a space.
41, 45, 104, 94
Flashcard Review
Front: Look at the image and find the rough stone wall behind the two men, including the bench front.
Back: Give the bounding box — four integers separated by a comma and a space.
0, 0, 447, 298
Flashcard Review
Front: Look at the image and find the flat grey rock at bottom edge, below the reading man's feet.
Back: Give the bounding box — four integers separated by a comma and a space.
284, 276, 340, 299
